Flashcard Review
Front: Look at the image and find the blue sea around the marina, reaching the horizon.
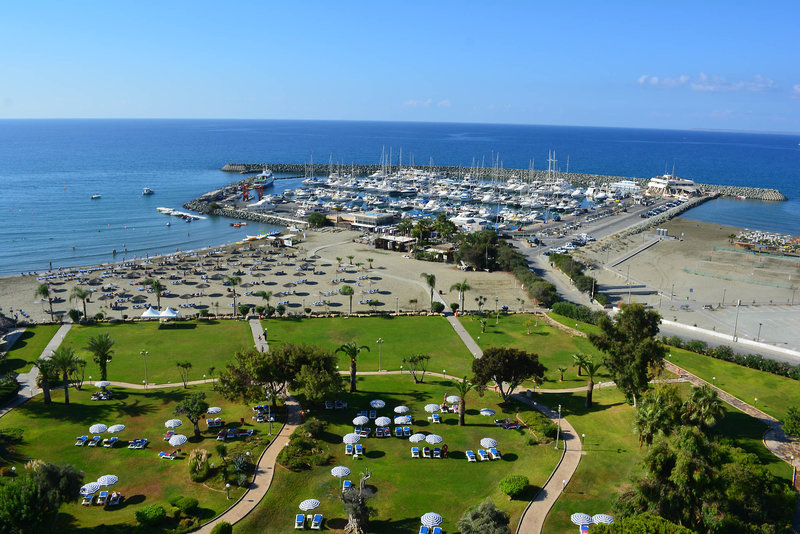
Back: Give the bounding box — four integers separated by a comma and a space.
0, 119, 800, 276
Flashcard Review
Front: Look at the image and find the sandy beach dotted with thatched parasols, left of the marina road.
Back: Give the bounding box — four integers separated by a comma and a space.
0, 230, 532, 322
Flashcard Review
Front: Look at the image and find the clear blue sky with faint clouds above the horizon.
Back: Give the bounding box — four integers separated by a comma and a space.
0, 0, 800, 132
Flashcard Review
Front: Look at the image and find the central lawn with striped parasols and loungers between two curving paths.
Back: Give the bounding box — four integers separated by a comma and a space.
234, 375, 560, 534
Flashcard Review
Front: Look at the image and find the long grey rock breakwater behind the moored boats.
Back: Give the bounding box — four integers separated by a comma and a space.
222, 163, 786, 201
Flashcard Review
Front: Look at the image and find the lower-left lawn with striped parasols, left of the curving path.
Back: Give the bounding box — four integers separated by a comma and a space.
0, 386, 277, 533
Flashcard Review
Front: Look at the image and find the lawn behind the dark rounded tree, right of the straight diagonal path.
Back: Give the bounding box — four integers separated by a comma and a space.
460, 314, 608, 389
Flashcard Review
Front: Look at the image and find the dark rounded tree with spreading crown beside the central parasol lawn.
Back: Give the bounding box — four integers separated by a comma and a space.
472, 347, 546, 401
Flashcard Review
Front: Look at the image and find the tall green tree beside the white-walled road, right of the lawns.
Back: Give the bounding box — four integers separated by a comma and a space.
589, 303, 665, 406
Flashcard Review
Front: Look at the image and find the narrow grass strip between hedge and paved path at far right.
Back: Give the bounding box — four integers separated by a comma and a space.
668, 348, 800, 426
